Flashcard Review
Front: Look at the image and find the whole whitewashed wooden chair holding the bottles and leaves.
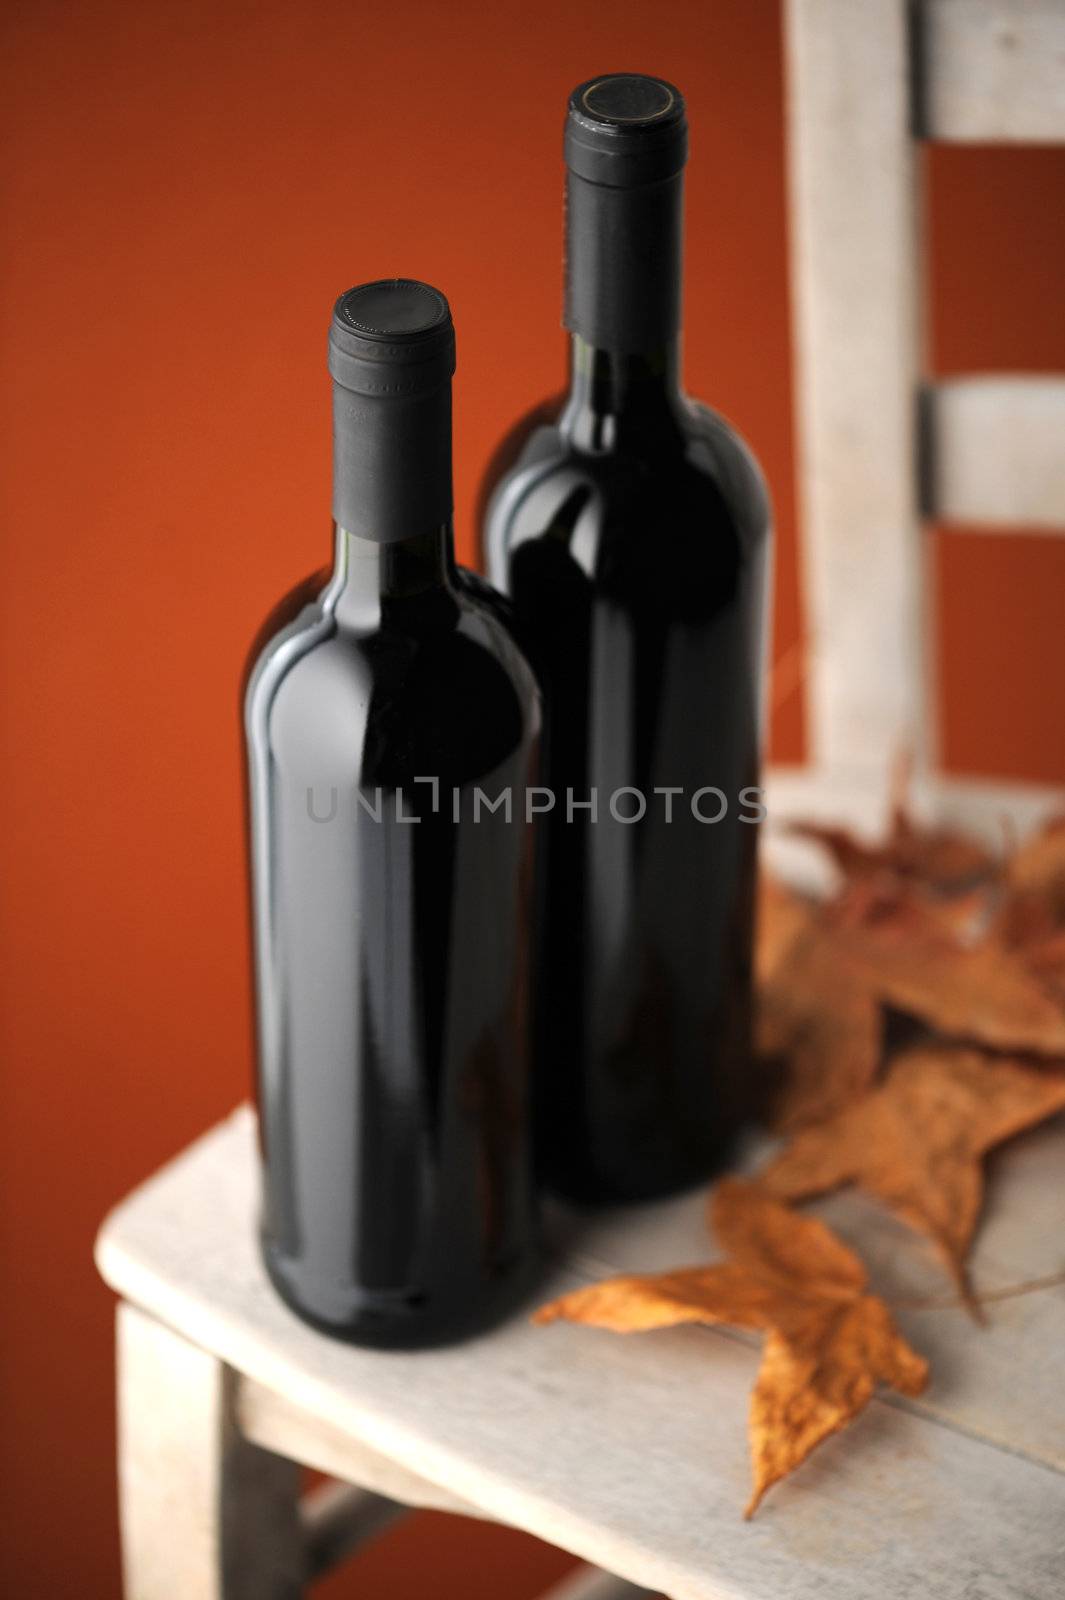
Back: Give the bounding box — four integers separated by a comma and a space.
98, 0, 1065, 1600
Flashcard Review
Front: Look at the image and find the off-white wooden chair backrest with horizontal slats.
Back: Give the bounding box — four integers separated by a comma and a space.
771, 0, 1065, 876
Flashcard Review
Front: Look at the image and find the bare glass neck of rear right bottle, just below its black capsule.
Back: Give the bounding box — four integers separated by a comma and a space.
558, 334, 683, 453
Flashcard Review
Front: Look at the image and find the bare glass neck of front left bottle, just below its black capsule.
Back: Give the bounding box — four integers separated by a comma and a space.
329, 520, 454, 630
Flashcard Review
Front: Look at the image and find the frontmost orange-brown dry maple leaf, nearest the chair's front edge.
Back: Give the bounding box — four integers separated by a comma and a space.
534, 1178, 927, 1517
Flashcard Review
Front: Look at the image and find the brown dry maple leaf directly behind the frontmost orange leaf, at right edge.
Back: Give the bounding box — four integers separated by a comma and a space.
761, 1045, 1065, 1294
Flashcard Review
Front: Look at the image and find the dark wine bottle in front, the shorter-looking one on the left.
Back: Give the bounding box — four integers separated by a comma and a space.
245, 280, 540, 1346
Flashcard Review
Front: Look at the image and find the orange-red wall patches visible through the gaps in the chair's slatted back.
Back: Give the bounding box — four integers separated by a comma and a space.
927, 146, 1065, 786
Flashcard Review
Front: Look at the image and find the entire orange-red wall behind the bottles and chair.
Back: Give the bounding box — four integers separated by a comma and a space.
0, 0, 1065, 1600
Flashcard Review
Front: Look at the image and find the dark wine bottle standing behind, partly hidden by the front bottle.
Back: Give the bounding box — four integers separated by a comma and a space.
483, 75, 769, 1203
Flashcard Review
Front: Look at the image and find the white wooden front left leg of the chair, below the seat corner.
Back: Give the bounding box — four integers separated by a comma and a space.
117, 1304, 304, 1600
